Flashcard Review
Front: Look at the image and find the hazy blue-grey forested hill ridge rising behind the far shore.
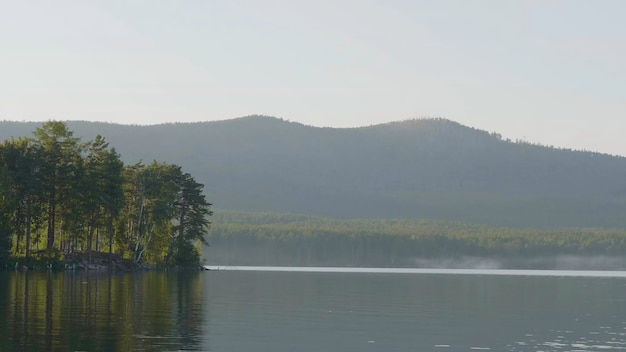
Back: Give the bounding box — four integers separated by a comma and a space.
0, 116, 626, 228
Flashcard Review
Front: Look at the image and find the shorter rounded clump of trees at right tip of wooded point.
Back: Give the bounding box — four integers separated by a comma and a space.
121, 161, 212, 265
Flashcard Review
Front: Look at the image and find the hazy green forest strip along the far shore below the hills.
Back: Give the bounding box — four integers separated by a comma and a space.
208, 211, 626, 267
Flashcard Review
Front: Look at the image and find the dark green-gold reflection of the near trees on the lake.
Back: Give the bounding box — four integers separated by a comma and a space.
0, 271, 202, 351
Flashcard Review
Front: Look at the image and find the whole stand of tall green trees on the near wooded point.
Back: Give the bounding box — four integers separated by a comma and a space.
0, 121, 211, 265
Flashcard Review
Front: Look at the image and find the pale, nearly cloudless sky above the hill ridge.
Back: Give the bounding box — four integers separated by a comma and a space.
0, 0, 626, 156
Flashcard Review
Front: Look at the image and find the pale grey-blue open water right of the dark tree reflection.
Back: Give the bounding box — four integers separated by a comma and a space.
205, 271, 626, 352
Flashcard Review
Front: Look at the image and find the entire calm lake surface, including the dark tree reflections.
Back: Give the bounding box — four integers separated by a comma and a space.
0, 268, 626, 352
